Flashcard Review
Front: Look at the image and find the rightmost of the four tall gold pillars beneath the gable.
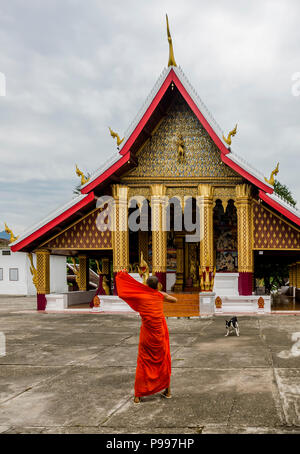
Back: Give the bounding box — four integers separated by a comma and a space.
235, 184, 253, 273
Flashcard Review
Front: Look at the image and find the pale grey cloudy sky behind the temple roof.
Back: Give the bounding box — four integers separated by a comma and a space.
0, 0, 300, 233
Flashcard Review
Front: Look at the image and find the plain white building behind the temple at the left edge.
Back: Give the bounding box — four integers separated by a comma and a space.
0, 240, 68, 296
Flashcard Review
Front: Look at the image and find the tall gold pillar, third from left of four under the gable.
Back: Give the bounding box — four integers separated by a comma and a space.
197, 184, 214, 290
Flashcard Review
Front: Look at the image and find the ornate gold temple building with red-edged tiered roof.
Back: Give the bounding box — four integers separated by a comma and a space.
11, 16, 300, 310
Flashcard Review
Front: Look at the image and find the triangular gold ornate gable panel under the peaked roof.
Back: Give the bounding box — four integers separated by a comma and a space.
123, 93, 241, 180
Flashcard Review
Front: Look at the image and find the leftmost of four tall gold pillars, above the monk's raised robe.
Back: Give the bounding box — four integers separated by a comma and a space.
112, 184, 129, 273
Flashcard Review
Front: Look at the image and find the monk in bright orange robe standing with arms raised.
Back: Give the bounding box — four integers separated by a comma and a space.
116, 271, 177, 403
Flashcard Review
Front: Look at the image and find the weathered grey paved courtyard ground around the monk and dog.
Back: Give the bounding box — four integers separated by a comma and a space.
0, 297, 300, 434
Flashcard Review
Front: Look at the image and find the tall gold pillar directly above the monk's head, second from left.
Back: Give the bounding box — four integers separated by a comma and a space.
151, 184, 167, 274
